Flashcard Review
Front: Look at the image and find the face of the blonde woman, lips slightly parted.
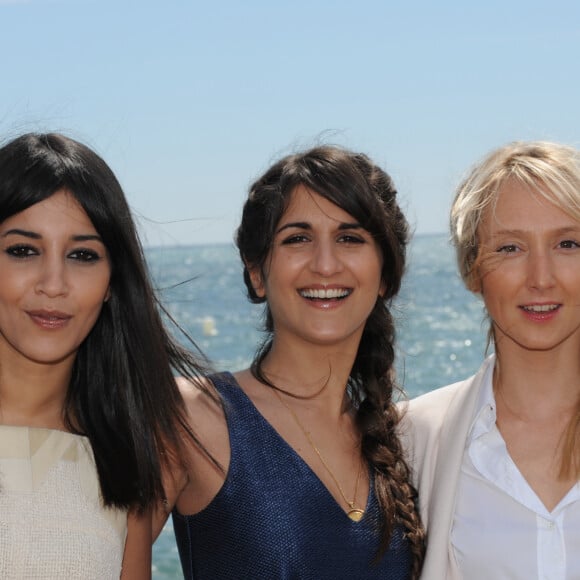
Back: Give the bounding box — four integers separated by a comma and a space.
478, 181, 580, 357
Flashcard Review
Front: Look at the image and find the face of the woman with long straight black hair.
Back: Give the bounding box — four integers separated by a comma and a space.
0, 191, 111, 372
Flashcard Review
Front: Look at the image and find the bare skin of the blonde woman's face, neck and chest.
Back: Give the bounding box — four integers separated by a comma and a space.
478, 181, 580, 510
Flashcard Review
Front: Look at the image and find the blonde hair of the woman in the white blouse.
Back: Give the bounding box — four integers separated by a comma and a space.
450, 141, 580, 479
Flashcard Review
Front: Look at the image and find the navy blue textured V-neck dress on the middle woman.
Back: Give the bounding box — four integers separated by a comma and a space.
173, 373, 411, 580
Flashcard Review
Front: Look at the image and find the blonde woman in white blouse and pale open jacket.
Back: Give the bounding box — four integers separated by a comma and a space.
403, 142, 580, 580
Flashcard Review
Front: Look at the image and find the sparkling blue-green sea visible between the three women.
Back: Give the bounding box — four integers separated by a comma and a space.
146, 234, 488, 580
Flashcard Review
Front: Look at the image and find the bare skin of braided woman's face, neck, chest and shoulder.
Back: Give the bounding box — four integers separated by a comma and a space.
154, 187, 384, 524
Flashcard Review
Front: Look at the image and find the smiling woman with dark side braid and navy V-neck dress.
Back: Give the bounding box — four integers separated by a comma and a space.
159, 147, 424, 580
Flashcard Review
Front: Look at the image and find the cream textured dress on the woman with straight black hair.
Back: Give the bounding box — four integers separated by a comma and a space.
0, 425, 127, 580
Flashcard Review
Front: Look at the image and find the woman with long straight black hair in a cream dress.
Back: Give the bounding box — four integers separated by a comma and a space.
0, 134, 208, 580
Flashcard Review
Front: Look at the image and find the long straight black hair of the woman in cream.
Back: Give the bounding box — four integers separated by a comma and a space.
0, 134, 213, 508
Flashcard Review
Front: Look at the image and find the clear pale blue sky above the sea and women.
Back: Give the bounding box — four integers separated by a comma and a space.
0, 0, 580, 246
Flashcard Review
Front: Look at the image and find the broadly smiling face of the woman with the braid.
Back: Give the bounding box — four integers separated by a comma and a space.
250, 186, 384, 344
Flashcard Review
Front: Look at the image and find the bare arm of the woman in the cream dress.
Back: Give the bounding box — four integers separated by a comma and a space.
121, 510, 152, 580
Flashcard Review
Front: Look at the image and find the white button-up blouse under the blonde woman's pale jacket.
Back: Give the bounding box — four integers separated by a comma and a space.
451, 369, 580, 580
